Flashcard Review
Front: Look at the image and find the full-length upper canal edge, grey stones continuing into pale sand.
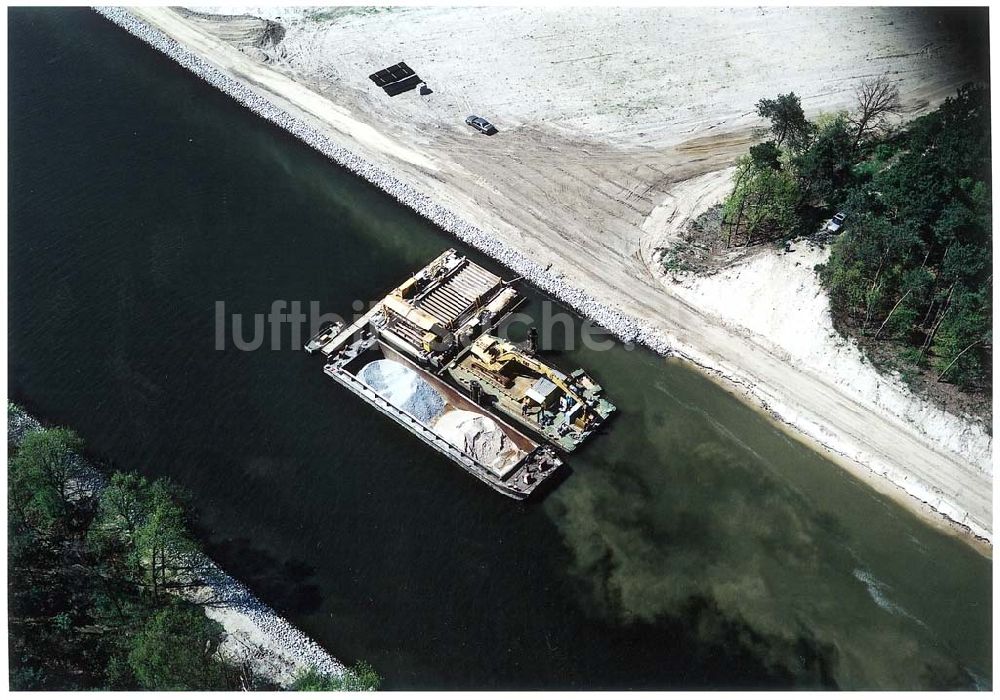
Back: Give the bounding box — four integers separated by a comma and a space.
92, 6, 993, 546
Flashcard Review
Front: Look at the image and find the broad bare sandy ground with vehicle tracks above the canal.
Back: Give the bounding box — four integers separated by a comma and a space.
119, 8, 992, 540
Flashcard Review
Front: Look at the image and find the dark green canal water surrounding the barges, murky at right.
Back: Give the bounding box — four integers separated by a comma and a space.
8, 10, 992, 688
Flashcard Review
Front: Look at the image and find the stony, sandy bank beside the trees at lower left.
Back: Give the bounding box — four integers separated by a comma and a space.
7, 410, 345, 687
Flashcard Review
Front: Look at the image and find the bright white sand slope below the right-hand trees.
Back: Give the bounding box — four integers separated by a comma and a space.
647, 178, 993, 476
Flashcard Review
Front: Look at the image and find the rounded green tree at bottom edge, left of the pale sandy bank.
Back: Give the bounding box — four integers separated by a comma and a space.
128, 601, 228, 691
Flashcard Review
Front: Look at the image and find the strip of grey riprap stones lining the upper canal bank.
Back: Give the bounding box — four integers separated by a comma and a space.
93, 7, 671, 355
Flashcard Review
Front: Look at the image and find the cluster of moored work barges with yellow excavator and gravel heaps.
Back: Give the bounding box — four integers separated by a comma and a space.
306, 250, 614, 500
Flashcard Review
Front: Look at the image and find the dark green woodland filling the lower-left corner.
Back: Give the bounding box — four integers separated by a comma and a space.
8, 418, 332, 690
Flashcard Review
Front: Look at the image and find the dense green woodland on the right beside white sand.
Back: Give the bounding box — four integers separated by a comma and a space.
722, 82, 993, 394
